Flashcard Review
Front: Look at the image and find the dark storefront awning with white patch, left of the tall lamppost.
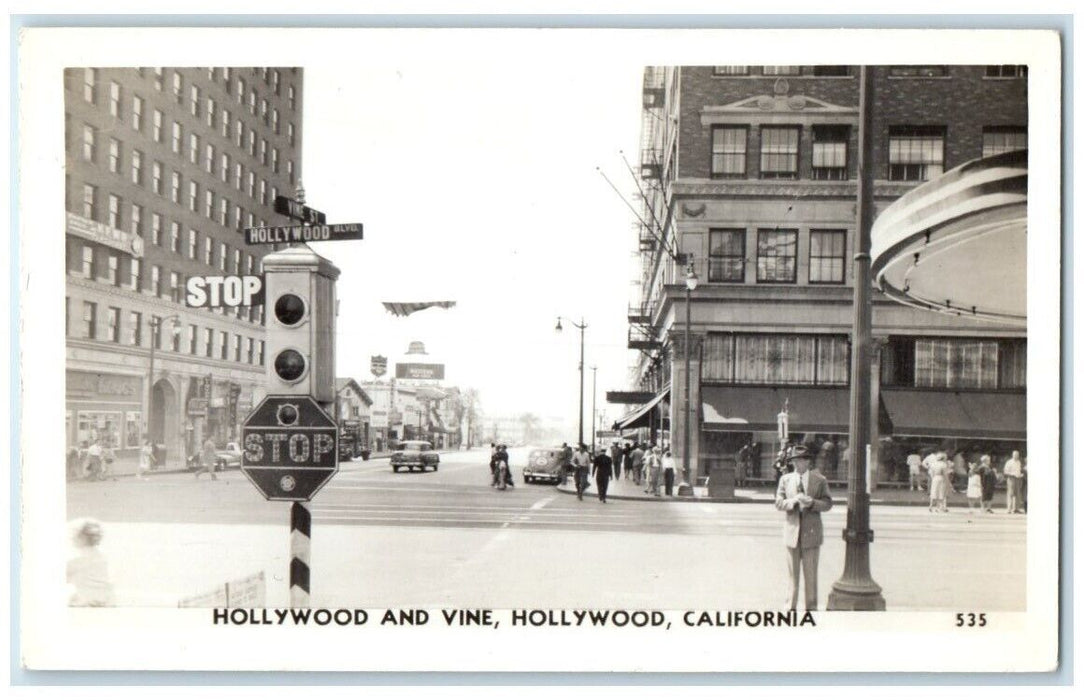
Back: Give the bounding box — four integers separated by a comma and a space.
700, 387, 850, 432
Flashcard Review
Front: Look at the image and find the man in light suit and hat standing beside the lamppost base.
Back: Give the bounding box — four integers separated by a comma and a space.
775, 445, 831, 610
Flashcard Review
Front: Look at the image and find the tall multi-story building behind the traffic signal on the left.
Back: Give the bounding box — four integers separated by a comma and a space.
64, 67, 302, 461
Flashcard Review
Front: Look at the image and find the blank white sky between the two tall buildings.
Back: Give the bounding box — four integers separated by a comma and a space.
301, 59, 643, 422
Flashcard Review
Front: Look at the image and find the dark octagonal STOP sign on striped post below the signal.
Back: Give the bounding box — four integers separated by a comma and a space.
241, 396, 338, 501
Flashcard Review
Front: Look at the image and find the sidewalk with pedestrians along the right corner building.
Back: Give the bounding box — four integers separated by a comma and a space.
557, 474, 1005, 511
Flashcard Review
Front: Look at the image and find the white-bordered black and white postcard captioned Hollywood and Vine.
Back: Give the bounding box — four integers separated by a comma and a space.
14, 28, 1062, 673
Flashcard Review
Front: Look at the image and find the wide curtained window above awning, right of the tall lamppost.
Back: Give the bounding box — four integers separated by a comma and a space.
915, 338, 997, 389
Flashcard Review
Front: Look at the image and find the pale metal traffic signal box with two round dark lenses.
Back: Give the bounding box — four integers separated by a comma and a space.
262, 245, 339, 403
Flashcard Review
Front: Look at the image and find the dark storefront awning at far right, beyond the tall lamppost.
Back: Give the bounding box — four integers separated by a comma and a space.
881, 389, 1028, 440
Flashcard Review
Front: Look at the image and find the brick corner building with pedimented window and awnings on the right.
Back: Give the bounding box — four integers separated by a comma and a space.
619, 65, 1028, 487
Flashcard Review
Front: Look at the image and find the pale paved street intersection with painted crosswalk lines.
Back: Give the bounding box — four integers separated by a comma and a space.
68, 451, 1027, 612
